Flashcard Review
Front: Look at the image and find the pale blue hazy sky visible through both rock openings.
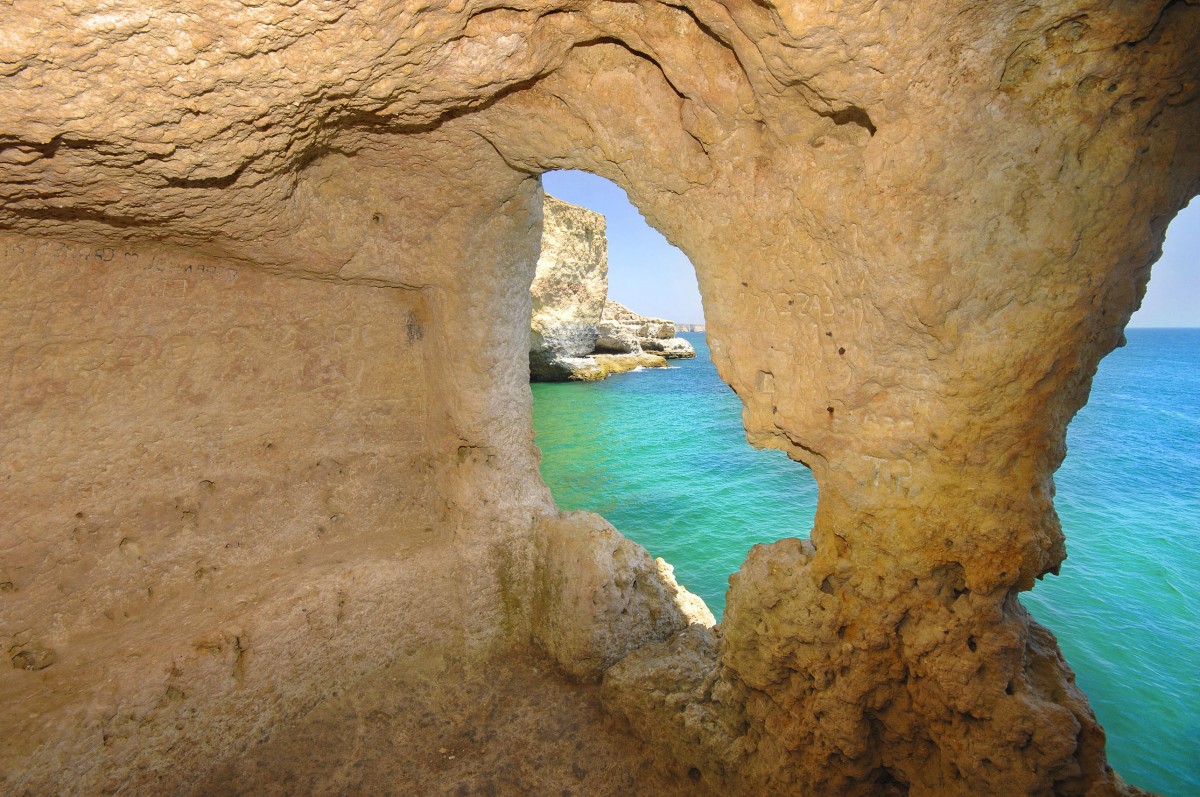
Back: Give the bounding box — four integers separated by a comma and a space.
542, 172, 1200, 326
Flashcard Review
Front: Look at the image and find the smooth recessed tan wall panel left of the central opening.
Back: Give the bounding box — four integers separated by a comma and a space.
0, 236, 438, 793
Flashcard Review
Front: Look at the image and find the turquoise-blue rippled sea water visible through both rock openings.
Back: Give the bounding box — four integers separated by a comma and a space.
532, 329, 1200, 797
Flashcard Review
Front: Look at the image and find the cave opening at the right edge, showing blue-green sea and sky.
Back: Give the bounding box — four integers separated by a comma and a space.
1021, 200, 1200, 795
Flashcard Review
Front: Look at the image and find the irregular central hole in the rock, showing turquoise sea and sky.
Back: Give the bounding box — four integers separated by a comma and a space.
529, 172, 816, 618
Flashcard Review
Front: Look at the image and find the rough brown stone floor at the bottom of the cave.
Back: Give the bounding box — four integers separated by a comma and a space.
192, 651, 709, 797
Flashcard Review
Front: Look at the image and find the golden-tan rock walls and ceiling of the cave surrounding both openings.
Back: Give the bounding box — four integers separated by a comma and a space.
0, 0, 1200, 795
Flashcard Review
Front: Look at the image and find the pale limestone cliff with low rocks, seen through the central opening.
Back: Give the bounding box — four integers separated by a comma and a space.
529, 194, 696, 382
